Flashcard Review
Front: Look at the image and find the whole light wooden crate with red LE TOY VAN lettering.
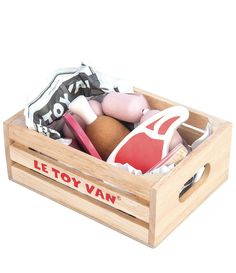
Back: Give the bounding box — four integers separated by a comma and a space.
4, 88, 232, 247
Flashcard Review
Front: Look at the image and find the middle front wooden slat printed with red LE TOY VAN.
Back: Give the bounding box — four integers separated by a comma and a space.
10, 143, 149, 222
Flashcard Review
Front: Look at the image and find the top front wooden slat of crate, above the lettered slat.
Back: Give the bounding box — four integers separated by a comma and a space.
9, 117, 153, 201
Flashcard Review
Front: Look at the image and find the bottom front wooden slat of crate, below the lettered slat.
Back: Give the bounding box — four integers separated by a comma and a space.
11, 163, 148, 244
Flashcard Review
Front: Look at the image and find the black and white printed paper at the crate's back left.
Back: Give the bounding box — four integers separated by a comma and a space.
25, 64, 133, 139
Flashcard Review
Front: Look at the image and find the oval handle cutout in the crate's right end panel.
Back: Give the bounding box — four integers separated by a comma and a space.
179, 163, 211, 203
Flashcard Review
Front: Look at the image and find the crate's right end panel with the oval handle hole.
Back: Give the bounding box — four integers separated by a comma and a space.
149, 122, 232, 246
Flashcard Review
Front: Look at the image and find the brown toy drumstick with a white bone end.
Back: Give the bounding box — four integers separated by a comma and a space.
69, 96, 129, 160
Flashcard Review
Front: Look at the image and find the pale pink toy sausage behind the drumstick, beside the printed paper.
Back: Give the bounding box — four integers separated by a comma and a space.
102, 92, 149, 123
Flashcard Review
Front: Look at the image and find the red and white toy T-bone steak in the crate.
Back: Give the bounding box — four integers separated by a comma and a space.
107, 106, 189, 173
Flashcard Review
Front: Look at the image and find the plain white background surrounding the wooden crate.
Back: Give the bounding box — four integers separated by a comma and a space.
0, 0, 236, 273
